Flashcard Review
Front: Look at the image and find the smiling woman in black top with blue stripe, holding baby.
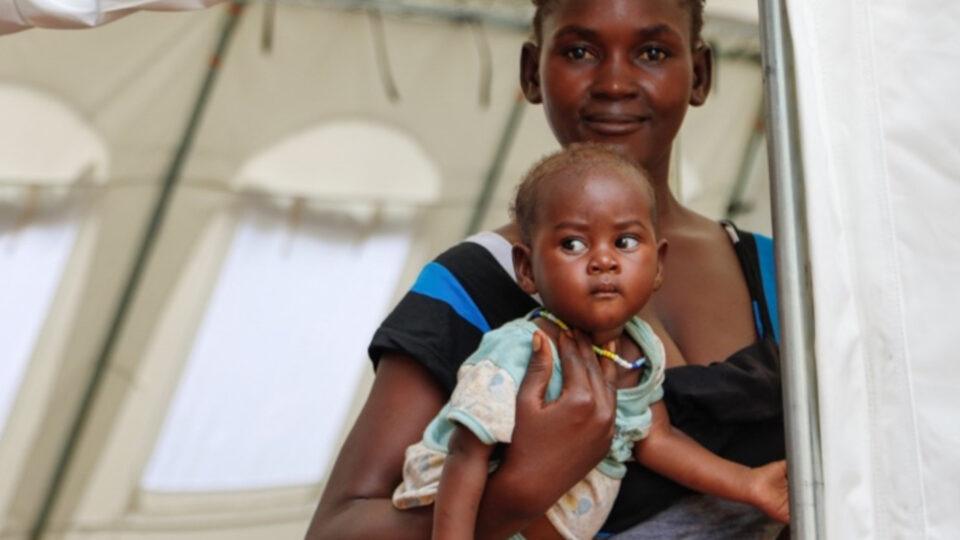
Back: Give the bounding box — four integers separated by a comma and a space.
308, 0, 783, 538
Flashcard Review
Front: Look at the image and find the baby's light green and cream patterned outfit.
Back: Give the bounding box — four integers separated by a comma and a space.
393, 318, 664, 538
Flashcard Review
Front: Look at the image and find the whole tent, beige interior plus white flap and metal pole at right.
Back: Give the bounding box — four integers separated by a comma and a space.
9, 0, 960, 538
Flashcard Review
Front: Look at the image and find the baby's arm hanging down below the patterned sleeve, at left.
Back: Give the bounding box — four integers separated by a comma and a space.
433, 425, 493, 540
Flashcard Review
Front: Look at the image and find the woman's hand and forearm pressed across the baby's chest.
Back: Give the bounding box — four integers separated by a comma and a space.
477, 331, 617, 537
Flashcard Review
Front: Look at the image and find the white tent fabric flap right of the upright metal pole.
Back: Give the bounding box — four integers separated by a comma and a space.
788, 0, 960, 538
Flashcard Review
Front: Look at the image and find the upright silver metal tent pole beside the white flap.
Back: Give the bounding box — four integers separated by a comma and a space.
758, 0, 824, 540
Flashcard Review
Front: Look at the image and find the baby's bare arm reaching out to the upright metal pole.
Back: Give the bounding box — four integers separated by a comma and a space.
634, 402, 790, 523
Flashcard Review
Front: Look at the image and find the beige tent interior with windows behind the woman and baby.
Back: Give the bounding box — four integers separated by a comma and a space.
0, 0, 770, 539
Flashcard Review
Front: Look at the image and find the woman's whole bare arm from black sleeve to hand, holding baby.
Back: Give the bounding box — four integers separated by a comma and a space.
307, 336, 616, 539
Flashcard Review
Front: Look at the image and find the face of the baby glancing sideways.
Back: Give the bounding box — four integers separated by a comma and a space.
530, 165, 661, 335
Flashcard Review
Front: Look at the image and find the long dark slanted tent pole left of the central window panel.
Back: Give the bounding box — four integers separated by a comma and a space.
30, 0, 246, 540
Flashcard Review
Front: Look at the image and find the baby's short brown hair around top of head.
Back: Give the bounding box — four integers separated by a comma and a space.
510, 143, 657, 244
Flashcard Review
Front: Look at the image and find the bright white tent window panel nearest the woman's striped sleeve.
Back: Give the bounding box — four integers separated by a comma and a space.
142, 200, 410, 493
